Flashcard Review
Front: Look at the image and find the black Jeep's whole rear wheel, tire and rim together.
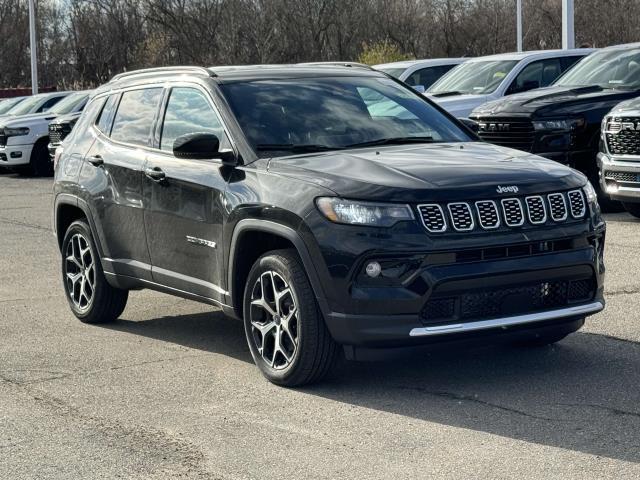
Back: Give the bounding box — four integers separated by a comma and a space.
61, 220, 129, 323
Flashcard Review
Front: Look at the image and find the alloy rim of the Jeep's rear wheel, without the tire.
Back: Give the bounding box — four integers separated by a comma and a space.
64, 233, 96, 311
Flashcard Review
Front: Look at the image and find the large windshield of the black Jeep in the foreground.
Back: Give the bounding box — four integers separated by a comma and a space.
221, 77, 471, 156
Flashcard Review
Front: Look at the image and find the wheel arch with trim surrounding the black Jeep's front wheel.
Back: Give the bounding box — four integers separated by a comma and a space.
227, 219, 326, 318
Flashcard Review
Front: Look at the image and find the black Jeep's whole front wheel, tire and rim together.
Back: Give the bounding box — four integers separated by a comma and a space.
243, 250, 339, 387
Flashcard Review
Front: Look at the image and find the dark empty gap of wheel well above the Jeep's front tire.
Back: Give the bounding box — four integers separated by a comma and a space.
231, 230, 296, 318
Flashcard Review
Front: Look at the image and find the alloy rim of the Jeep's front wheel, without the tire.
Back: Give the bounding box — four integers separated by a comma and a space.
249, 270, 299, 370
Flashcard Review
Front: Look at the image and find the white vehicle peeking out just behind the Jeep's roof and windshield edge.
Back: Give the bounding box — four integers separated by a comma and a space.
373, 58, 469, 93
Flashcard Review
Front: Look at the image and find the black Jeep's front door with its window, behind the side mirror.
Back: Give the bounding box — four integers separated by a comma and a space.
143, 84, 231, 300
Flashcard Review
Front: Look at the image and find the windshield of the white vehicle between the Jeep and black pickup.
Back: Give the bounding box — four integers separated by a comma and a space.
427, 60, 518, 95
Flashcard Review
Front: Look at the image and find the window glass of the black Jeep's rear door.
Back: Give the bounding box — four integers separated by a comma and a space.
111, 87, 162, 146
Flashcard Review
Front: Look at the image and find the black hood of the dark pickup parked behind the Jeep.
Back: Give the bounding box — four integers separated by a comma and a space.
471, 86, 640, 118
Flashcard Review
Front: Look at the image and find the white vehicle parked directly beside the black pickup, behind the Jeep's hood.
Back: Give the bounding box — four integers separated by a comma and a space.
426, 48, 594, 118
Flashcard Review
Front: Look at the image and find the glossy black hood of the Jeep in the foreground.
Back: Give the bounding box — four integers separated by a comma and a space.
268, 142, 586, 202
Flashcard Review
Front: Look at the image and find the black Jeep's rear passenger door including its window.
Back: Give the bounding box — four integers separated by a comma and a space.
81, 86, 163, 280
